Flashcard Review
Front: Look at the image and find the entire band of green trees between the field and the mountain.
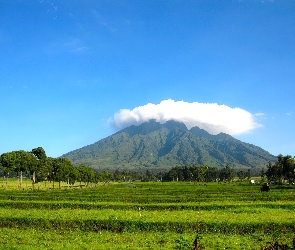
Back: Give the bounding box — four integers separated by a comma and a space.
0, 147, 295, 189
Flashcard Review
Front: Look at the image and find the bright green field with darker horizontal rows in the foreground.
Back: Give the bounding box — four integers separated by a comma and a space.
0, 181, 295, 249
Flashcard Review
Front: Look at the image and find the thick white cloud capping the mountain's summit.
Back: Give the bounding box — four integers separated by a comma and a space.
108, 99, 262, 135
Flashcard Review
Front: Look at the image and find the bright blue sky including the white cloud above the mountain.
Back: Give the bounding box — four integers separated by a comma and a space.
0, 0, 295, 157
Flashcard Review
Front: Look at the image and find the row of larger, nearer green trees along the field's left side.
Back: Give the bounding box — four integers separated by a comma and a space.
0, 147, 111, 189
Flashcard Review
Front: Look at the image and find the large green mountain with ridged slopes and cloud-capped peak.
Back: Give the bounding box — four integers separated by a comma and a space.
62, 120, 276, 170
